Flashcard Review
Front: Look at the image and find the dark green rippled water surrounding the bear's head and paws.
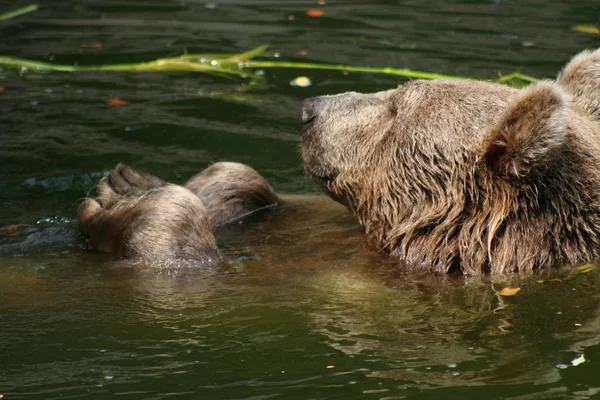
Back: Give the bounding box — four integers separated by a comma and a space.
0, 0, 600, 400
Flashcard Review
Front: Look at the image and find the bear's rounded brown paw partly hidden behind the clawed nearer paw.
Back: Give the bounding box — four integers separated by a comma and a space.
185, 162, 279, 229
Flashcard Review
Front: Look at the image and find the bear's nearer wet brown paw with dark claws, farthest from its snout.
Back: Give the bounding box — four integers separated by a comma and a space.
77, 164, 221, 266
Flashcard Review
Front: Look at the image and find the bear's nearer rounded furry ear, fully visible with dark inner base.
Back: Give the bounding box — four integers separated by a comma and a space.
482, 82, 568, 175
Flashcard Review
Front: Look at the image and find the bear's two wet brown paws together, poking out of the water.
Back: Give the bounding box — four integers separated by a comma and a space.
78, 162, 277, 266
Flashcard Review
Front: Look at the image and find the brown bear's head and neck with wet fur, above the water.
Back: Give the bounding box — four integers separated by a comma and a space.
302, 50, 600, 275
